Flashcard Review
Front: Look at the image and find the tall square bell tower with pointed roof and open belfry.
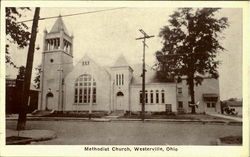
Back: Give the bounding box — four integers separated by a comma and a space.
39, 15, 73, 111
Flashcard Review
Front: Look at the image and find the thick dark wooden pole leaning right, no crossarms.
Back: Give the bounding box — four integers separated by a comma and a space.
17, 7, 40, 130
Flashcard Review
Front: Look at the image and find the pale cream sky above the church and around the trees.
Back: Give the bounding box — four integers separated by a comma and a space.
6, 7, 242, 100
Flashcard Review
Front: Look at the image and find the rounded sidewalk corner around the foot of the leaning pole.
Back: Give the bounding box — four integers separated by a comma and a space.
6, 129, 57, 145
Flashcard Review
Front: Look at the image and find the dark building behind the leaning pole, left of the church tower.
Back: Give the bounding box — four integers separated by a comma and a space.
5, 78, 38, 114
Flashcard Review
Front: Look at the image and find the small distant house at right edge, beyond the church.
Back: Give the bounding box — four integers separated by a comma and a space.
222, 99, 242, 115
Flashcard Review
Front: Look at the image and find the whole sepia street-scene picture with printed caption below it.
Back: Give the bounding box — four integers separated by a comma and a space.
1, 2, 248, 157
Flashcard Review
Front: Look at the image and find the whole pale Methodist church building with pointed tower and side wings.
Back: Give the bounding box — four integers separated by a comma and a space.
38, 16, 220, 113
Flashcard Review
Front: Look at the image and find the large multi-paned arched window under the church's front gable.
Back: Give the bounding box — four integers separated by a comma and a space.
74, 74, 96, 104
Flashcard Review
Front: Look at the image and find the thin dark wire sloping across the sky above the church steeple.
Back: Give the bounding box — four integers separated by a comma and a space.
17, 7, 126, 23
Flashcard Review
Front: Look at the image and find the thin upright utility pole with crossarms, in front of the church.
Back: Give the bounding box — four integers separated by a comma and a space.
135, 29, 154, 121
